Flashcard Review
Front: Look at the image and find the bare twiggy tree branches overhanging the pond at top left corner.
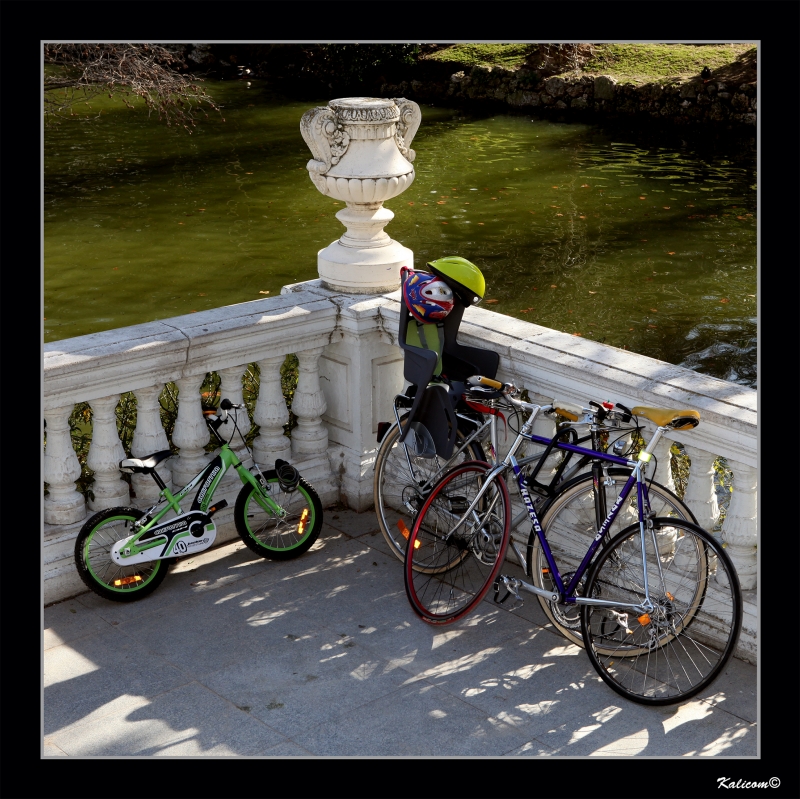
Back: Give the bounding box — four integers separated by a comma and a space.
44, 44, 224, 133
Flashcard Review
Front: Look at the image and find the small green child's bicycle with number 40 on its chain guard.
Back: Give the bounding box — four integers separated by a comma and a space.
75, 399, 322, 602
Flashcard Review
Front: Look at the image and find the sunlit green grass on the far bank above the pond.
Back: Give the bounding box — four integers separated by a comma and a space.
422, 42, 756, 83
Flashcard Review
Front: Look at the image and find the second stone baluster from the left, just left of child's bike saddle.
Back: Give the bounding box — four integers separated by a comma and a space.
86, 394, 130, 510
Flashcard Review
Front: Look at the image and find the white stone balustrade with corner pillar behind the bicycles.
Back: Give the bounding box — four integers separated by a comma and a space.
43, 280, 758, 657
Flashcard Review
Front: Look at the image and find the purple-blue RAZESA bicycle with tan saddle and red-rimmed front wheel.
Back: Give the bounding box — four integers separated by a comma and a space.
404, 376, 742, 705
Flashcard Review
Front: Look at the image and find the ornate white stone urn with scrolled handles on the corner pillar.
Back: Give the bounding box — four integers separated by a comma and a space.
300, 97, 421, 294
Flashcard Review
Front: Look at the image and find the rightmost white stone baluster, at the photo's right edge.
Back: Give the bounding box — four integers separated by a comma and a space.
722, 463, 758, 591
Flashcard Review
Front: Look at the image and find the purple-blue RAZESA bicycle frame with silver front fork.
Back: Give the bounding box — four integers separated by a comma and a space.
447, 406, 665, 614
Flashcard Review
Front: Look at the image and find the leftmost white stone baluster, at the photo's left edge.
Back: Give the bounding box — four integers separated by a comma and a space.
43, 405, 86, 524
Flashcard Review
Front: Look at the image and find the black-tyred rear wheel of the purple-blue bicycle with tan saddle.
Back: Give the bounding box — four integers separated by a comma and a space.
581, 518, 742, 705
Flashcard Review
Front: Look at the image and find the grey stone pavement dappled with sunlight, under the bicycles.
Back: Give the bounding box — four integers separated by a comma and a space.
43, 509, 759, 758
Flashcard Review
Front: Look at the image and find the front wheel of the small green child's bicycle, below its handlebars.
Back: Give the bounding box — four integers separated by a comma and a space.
233, 469, 322, 560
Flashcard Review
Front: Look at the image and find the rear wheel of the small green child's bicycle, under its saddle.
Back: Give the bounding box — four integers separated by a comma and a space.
75, 508, 169, 602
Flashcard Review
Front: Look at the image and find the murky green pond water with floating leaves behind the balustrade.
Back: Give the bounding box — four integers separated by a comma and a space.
43, 81, 757, 386
